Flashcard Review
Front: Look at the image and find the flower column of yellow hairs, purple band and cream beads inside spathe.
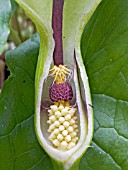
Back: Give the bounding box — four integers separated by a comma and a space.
47, 65, 79, 151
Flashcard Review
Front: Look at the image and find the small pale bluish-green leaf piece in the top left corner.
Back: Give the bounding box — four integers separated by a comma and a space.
0, 0, 11, 54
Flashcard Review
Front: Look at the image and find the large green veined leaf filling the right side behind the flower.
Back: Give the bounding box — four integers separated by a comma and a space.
80, 0, 128, 170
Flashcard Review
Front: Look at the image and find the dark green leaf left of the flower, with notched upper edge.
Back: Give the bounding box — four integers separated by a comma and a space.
0, 35, 51, 170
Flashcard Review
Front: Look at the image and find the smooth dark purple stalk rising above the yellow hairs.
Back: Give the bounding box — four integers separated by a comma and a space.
52, 0, 64, 66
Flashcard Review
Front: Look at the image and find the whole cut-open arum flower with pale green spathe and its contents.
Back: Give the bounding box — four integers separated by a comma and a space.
17, 0, 101, 170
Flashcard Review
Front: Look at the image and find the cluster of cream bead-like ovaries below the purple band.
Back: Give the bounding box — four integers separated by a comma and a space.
47, 102, 78, 150
